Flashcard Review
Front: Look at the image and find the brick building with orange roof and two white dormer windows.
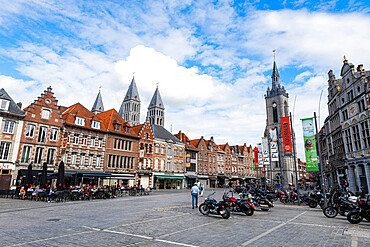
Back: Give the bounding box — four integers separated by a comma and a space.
60, 103, 107, 185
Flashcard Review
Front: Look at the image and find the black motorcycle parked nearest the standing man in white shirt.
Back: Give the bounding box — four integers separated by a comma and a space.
199, 192, 230, 219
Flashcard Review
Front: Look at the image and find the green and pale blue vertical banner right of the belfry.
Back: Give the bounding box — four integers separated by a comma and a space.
302, 118, 319, 172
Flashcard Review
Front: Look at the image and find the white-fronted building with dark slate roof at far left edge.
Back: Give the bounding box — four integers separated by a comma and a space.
0, 88, 25, 190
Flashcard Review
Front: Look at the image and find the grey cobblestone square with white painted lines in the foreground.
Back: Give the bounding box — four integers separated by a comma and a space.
0, 190, 370, 246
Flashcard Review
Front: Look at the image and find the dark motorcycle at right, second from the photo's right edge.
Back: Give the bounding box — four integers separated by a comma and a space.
323, 194, 357, 218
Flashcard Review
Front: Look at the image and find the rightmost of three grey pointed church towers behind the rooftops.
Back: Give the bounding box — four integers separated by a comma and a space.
147, 86, 164, 127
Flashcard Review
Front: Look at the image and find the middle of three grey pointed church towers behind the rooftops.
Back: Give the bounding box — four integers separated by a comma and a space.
118, 77, 140, 126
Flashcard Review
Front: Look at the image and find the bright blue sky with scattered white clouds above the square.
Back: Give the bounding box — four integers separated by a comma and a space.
0, 0, 370, 160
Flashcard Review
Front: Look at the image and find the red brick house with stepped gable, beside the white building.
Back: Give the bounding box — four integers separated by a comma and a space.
17, 87, 63, 183
